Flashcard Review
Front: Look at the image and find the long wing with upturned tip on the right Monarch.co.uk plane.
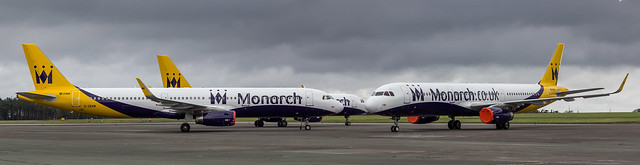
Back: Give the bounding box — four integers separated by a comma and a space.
470, 73, 629, 110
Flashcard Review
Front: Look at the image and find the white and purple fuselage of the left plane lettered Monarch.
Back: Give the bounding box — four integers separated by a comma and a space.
78, 88, 343, 117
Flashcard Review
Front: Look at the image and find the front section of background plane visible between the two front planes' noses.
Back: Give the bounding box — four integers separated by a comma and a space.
329, 93, 367, 126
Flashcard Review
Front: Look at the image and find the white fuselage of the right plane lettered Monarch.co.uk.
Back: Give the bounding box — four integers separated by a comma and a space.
366, 83, 544, 116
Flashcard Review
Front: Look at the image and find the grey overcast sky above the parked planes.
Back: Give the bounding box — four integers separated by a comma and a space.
0, 0, 640, 112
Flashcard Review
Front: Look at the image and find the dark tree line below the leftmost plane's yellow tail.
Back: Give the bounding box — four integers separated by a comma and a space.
0, 98, 103, 120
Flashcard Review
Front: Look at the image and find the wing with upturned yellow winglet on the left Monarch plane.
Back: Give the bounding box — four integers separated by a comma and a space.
136, 78, 233, 114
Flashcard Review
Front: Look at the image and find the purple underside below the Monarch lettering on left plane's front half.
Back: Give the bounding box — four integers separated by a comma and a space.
233, 105, 334, 117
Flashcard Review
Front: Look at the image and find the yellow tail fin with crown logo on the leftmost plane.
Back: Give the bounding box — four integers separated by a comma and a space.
22, 44, 73, 90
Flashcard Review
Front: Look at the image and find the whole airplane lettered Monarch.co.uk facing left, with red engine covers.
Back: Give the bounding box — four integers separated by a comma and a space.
365, 43, 629, 132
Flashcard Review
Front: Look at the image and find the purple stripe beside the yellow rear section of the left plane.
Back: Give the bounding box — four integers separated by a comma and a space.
76, 87, 158, 118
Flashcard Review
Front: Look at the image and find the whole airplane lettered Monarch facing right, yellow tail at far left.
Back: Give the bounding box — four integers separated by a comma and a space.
16, 44, 343, 132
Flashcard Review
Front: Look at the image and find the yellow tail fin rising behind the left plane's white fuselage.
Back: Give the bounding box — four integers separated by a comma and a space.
158, 55, 191, 88
